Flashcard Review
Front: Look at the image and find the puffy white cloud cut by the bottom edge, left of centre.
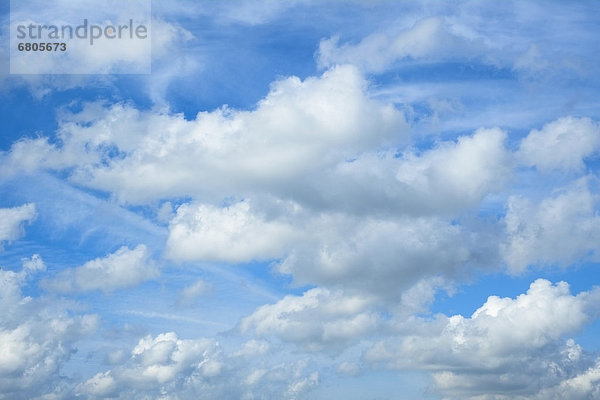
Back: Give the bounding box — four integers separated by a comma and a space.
75, 332, 319, 400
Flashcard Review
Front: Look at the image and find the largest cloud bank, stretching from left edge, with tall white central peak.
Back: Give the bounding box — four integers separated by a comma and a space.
4, 66, 510, 222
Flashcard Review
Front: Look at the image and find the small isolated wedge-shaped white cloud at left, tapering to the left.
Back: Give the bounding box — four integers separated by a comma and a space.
43, 244, 158, 292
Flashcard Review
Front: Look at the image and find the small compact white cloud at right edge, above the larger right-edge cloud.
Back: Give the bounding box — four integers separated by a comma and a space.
517, 117, 600, 172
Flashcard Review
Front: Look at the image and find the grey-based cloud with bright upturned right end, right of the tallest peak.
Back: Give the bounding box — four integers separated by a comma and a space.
292, 128, 511, 215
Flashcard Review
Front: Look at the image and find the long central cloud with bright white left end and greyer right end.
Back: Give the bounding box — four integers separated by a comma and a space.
167, 195, 482, 299
